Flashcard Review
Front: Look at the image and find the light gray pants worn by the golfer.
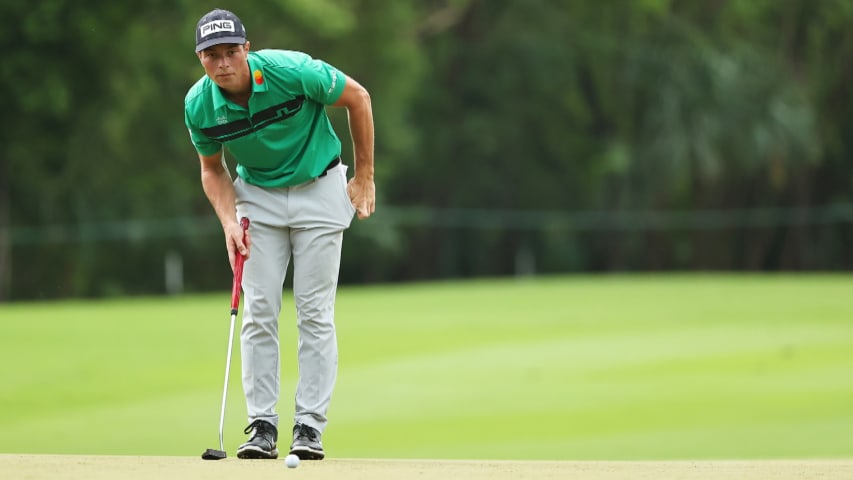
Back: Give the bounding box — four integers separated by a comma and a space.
234, 164, 355, 432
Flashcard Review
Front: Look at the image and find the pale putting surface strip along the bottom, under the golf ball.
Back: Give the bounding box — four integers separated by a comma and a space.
0, 455, 853, 480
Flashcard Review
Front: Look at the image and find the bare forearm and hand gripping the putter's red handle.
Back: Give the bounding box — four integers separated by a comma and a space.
198, 151, 251, 269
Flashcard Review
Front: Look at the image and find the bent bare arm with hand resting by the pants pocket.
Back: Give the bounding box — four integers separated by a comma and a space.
333, 76, 376, 219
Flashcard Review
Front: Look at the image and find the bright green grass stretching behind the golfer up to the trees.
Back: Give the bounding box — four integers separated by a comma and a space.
0, 274, 853, 460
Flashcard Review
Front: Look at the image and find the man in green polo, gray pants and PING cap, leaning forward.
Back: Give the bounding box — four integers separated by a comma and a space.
184, 9, 375, 460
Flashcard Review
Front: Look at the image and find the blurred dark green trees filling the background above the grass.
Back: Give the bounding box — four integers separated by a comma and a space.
0, 0, 853, 299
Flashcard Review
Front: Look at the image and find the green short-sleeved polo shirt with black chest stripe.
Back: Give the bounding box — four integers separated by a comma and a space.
184, 50, 346, 187
